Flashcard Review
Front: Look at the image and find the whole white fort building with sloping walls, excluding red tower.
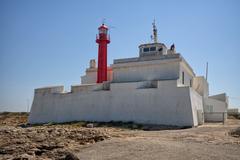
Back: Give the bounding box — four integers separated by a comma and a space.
29, 22, 228, 126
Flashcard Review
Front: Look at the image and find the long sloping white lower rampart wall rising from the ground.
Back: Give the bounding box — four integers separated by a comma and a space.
29, 81, 201, 126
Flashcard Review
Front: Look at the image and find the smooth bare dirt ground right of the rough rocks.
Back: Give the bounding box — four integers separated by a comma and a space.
77, 120, 240, 160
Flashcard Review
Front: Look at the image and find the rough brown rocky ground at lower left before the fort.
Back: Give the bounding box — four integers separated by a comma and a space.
0, 113, 110, 160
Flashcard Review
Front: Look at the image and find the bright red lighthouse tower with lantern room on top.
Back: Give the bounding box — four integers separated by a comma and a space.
96, 24, 110, 83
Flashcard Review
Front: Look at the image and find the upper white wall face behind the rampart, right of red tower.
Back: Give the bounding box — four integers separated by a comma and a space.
112, 59, 179, 82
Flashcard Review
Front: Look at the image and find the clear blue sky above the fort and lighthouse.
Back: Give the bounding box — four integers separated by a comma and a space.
0, 0, 240, 112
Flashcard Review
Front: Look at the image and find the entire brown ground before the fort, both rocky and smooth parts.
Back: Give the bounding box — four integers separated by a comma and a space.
0, 115, 240, 160
